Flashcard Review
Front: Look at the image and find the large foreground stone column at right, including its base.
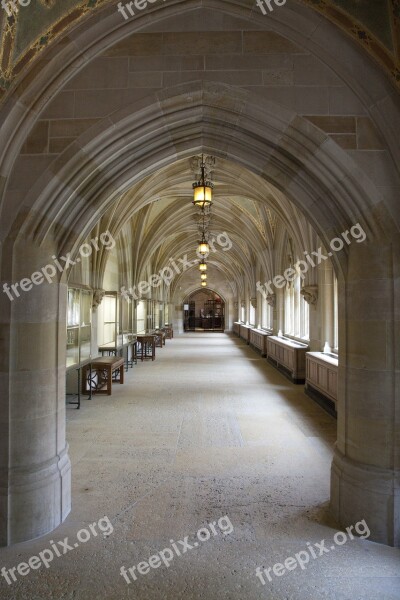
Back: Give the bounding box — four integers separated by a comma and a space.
331, 237, 400, 546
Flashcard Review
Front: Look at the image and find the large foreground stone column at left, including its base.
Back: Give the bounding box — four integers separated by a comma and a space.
0, 244, 71, 545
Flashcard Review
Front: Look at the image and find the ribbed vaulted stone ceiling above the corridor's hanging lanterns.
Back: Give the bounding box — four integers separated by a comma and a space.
97, 157, 315, 296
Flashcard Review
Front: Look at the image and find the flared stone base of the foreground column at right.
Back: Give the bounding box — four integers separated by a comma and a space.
330, 448, 400, 547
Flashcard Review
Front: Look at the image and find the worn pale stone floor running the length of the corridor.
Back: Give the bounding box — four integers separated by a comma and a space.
0, 333, 400, 600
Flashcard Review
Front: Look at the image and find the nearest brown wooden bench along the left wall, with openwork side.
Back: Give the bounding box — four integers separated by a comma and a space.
82, 356, 125, 396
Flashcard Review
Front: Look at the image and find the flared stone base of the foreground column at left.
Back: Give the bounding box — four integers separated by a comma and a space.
7, 445, 71, 545
